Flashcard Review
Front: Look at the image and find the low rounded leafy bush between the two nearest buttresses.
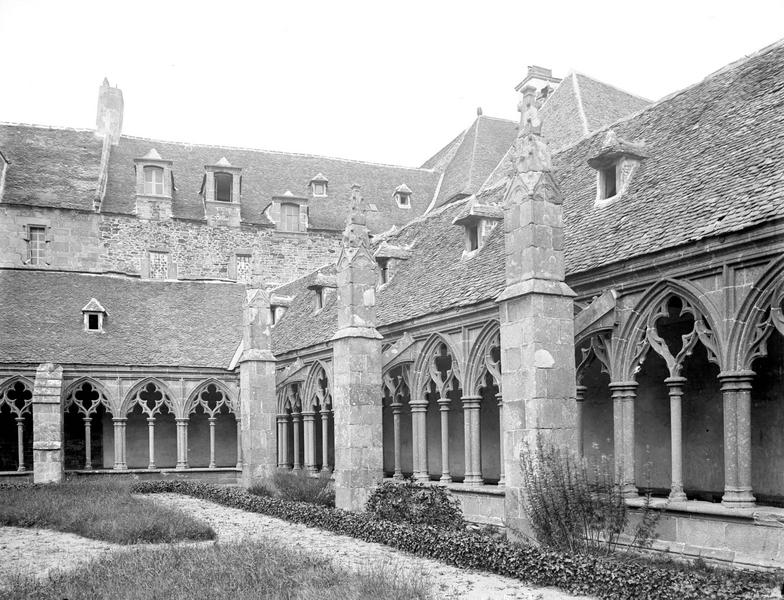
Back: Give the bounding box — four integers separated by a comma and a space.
366, 479, 465, 529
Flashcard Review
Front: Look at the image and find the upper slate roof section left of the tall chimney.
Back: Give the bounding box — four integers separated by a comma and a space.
0, 123, 102, 210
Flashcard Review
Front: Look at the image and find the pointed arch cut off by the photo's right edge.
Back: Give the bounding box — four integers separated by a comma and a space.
727, 256, 784, 371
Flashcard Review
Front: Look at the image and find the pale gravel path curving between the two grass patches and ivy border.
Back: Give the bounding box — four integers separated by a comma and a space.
0, 494, 586, 600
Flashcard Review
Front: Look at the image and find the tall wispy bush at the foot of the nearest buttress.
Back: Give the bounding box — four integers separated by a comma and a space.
520, 435, 662, 554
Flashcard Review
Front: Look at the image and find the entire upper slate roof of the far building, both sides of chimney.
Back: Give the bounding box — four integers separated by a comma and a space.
0, 123, 440, 231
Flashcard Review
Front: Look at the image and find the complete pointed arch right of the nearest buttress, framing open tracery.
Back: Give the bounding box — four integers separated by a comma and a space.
610, 278, 726, 381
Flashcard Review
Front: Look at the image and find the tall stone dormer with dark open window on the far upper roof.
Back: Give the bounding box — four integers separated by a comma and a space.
199, 156, 242, 227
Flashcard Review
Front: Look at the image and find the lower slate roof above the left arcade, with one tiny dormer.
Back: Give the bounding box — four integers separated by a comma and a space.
0, 270, 245, 368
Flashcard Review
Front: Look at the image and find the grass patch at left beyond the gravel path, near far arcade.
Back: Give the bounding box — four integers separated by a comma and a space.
0, 480, 215, 544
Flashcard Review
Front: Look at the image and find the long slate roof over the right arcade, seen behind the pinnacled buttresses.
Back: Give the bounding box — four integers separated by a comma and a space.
273, 42, 784, 353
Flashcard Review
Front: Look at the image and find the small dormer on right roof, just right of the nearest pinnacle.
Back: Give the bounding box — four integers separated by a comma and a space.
588, 129, 648, 206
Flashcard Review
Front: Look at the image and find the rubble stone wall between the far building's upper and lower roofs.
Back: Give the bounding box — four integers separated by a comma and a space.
0, 206, 340, 285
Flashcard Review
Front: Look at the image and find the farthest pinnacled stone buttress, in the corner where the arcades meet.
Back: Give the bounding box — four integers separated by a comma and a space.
237, 276, 278, 487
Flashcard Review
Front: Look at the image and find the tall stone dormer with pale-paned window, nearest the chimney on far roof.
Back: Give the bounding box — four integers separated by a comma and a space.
133, 148, 174, 221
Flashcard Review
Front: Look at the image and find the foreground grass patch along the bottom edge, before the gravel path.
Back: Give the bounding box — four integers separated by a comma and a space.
0, 542, 432, 600
